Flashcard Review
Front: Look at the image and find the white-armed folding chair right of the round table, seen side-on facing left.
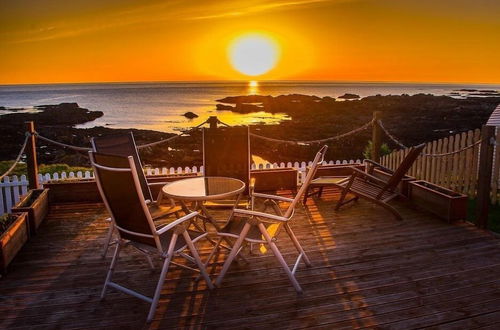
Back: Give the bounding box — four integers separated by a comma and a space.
212, 146, 328, 293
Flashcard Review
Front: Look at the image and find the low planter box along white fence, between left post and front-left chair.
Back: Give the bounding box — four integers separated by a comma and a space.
43, 179, 102, 203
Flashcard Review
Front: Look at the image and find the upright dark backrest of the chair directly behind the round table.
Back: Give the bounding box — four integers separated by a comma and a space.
203, 126, 251, 193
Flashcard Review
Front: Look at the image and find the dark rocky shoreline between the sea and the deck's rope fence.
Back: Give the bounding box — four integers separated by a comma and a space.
0, 94, 500, 167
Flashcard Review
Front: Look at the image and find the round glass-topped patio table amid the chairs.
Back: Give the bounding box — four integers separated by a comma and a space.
162, 176, 245, 230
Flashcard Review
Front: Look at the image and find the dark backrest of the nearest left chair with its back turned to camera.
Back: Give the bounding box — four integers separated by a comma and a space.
89, 152, 161, 251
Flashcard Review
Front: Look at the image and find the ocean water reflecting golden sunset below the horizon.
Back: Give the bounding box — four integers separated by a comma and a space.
0, 81, 500, 132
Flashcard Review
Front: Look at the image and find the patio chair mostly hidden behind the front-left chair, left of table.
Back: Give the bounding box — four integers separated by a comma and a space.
90, 132, 181, 257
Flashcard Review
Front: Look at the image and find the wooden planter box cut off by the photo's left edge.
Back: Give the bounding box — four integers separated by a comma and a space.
0, 212, 29, 274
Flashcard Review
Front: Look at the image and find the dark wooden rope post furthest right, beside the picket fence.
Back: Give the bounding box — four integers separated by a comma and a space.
476, 125, 495, 229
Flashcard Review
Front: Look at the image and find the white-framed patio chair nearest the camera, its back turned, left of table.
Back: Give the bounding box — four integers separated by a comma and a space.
89, 152, 213, 322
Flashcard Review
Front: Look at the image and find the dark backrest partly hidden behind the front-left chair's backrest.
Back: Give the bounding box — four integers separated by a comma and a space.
90, 132, 153, 201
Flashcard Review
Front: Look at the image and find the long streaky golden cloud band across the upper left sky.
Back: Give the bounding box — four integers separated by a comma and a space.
0, 0, 352, 44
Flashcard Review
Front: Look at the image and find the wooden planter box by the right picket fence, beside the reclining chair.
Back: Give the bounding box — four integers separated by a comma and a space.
409, 180, 467, 222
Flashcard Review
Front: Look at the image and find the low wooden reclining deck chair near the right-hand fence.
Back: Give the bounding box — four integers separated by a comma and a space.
335, 144, 425, 220
